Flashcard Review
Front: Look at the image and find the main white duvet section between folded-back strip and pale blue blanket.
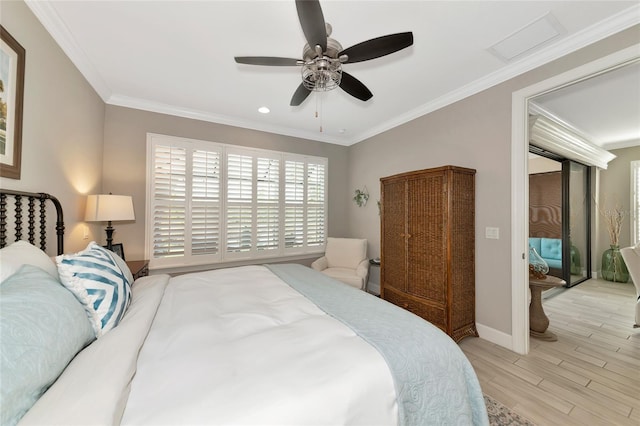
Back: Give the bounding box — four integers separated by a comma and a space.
122, 266, 397, 425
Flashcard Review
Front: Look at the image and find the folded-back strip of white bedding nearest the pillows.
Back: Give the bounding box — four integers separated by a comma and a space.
18, 275, 169, 426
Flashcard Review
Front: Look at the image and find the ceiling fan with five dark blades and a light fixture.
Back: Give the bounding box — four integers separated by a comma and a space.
235, 0, 413, 106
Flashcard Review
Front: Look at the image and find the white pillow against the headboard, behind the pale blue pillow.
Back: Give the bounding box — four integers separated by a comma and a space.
0, 240, 58, 282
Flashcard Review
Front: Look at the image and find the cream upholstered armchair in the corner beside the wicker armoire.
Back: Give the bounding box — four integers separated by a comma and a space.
311, 237, 369, 290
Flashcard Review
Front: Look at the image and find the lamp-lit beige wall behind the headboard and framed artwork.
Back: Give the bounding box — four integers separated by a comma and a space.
0, 1, 105, 254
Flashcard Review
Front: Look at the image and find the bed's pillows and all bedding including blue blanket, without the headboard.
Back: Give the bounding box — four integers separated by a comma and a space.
0, 191, 488, 425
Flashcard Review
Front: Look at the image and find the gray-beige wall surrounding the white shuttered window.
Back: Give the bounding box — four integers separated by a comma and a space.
102, 105, 350, 259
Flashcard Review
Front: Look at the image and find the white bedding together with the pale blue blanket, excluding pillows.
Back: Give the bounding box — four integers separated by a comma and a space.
19, 265, 488, 426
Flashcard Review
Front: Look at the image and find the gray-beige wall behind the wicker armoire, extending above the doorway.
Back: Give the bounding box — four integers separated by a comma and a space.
349, 26, 640, 335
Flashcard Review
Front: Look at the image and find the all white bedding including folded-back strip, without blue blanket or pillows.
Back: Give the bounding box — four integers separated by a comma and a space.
20, 266, 398, 425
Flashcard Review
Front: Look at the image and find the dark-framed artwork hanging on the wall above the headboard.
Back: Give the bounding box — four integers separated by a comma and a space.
0, 25, 25, 179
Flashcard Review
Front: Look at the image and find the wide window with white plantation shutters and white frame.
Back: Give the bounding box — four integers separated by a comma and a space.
146, 134, 327, 267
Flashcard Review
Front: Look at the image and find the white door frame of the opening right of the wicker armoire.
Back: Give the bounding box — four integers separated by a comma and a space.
511, 44, 640, 354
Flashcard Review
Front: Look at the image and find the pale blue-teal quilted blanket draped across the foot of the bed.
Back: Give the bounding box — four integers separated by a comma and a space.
267, 264, 489, 426
